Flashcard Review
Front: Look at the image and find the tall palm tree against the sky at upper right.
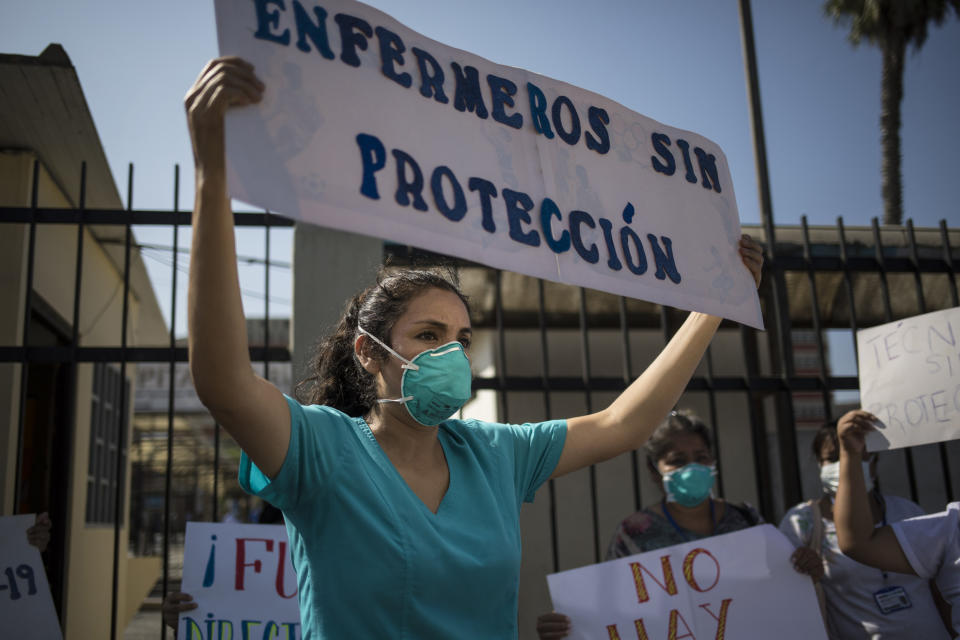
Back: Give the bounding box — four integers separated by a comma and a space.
823, 0, 960, 224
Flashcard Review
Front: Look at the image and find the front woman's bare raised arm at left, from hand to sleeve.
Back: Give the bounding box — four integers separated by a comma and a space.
184, 58, 290, 477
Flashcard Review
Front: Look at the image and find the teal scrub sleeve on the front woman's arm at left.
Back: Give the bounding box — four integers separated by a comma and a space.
239, 396, 350, 511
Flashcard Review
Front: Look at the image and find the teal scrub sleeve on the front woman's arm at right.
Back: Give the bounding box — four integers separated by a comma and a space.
504, 420, 567, 503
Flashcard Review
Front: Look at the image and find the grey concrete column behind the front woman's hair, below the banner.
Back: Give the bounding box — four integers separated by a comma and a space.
290, 224, 383, 392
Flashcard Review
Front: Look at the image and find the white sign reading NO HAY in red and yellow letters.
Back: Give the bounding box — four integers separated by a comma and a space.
547, 525, 827, 640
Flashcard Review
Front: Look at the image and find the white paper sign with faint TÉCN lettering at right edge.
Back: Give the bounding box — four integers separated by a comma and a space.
857, 307, 960, 451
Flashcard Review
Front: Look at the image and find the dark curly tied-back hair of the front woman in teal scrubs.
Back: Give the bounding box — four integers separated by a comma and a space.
295, 268, 470, 417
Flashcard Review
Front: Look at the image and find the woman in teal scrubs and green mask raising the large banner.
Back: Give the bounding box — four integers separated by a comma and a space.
185, 57, 763, 640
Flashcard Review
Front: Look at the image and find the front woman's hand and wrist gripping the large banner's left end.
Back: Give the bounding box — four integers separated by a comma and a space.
183, 56, 264, 167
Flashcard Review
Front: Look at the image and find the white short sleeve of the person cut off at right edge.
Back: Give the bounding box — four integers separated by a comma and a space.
890, 502, 960, 579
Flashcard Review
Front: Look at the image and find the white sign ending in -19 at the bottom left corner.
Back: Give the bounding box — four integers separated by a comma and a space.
0, 514, 63, 640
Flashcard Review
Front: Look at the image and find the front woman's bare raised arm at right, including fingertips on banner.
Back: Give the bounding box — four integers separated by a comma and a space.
553, 235, 763, 477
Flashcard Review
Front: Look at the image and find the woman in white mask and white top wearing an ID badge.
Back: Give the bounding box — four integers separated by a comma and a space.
780, 412, 950, 640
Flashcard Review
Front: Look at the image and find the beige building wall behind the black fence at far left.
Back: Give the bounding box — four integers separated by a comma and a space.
0, 152, 164, 640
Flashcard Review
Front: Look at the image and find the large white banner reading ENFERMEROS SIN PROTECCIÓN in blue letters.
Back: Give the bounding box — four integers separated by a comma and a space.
215, 0, 763, 328
